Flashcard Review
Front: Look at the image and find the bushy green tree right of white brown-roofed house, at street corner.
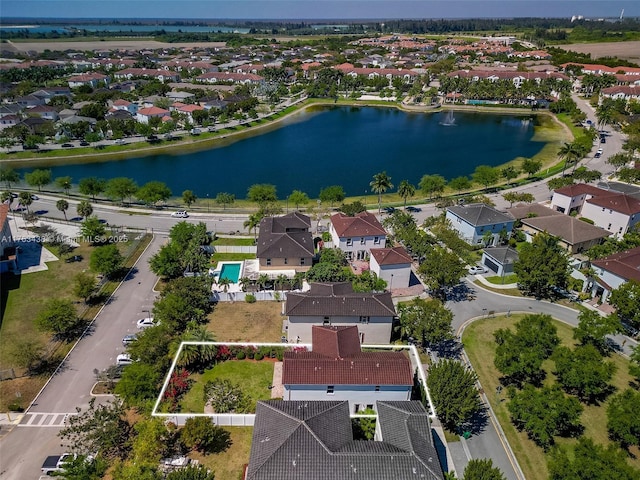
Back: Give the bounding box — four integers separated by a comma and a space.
398, 297, 453, 345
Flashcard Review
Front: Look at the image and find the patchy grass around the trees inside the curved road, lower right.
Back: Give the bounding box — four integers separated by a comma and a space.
463, 314, 640, 480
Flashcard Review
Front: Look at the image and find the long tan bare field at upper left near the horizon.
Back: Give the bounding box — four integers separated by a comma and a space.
8, 39, 226, 53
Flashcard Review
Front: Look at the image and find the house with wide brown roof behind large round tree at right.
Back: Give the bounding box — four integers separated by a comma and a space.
521, 215, 611, 254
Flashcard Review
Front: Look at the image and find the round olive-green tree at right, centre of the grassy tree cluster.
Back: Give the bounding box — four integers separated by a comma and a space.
553, 345, 616, 403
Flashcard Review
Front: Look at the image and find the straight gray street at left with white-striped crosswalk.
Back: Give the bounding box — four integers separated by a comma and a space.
0, 236, 166, 480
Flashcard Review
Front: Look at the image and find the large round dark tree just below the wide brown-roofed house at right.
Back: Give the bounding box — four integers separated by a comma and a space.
513, 232, 570, 297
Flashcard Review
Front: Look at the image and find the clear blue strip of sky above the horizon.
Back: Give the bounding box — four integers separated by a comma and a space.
0, 0, 640, 20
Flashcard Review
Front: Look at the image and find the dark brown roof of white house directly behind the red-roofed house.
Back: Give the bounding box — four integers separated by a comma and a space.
285, 282, 396, 317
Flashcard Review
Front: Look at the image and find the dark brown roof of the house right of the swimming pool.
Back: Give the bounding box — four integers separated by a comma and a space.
257, 212, 315, 258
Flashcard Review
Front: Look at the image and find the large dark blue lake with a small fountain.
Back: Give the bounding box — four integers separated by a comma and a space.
19, 107, 545, 198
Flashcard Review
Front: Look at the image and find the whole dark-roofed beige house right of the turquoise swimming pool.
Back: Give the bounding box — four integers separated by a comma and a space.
256, 212, 315, 272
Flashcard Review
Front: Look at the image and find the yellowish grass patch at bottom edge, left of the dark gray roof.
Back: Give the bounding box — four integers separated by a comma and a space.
189, 427, 253, 480
